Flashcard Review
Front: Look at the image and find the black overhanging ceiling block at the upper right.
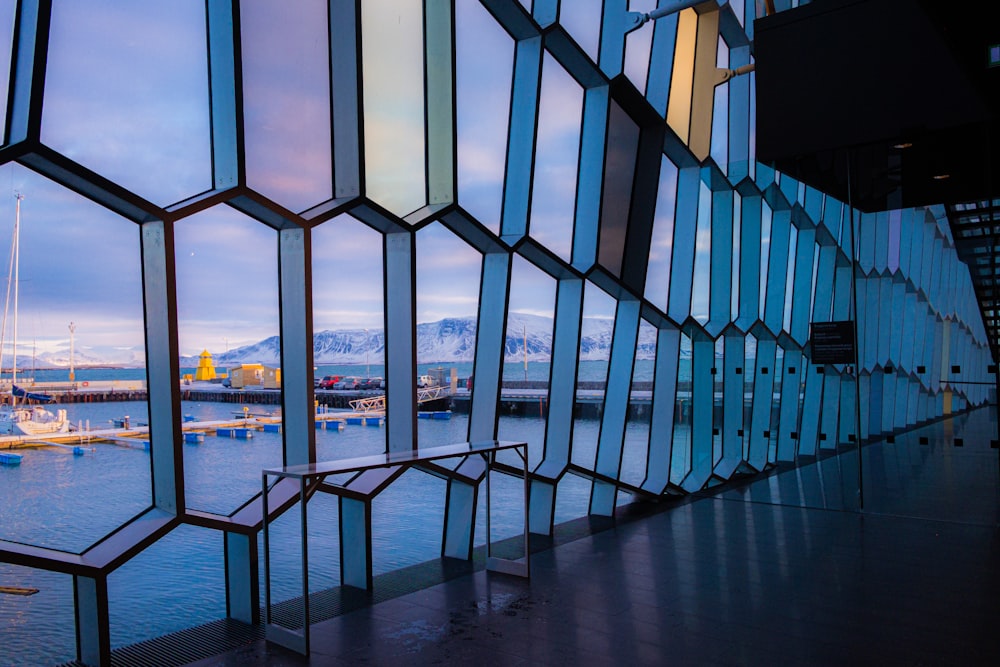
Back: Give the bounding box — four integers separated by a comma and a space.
754, 0, 1000, 211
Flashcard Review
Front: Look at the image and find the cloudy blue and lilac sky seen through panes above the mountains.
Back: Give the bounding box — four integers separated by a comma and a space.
0, 0, 672, 362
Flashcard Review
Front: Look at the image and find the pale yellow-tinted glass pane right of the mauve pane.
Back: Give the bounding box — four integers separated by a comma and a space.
361, 0, 427, 216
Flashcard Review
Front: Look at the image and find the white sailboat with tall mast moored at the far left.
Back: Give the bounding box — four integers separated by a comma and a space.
0, 193, 69, 436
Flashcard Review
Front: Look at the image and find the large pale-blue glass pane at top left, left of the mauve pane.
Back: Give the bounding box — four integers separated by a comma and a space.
42, 0, 212, 206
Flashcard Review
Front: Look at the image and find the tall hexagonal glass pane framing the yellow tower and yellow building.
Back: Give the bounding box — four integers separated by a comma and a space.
174, 206, 282, 514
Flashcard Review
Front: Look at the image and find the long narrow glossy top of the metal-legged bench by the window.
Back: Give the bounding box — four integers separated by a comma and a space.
262, 440, 528, 479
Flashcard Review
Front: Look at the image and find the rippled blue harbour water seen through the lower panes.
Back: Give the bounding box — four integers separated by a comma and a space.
0, 367, 649, 666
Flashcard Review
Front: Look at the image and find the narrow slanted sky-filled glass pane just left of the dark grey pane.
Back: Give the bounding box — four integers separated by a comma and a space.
530, 55, 583, 261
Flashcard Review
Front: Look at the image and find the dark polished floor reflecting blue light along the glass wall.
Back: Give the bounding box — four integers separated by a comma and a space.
188, 409, 1000, 667
